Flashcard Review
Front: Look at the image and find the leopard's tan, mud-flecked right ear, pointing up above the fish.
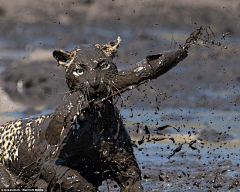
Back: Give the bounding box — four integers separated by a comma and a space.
95, 36, 122, 58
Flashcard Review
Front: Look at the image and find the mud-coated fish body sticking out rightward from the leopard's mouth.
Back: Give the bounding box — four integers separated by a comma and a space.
109, 48, 188, 93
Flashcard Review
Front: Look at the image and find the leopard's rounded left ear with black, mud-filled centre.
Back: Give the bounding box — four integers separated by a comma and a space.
53, 49, 76, 69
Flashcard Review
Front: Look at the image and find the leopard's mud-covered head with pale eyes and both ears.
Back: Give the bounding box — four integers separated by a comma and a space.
53, 37, 121, 98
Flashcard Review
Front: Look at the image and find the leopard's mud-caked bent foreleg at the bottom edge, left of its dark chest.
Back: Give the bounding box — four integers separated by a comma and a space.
42, 162, 97, 192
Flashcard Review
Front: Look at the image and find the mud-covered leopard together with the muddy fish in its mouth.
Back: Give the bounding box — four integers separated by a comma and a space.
0, 35, 189, 192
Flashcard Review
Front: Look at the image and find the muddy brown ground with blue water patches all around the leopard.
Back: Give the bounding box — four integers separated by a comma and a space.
0, 0, 240, 191
